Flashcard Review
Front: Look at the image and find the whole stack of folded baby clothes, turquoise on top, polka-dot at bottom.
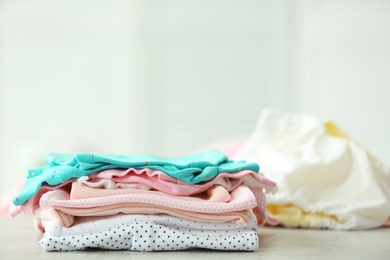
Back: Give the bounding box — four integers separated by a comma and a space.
10, 150, 277, 251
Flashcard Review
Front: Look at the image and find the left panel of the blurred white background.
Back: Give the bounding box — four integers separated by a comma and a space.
0, 0, 135, 190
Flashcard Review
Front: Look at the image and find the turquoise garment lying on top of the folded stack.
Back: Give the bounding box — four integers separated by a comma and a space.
13, 150, 259, 206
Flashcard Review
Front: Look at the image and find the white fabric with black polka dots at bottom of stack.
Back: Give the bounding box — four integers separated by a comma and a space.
39, 222, 258, 251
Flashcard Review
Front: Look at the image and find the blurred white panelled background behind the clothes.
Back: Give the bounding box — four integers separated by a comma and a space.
0, 0, 390, 192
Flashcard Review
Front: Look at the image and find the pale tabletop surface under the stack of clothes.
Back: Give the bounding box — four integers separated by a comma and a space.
0, 216, 390, 260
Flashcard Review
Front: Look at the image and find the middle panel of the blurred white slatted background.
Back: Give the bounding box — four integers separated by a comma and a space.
133, 0, 290, 155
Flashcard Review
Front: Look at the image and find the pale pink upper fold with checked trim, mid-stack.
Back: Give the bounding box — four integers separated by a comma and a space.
40, 183, 257, 214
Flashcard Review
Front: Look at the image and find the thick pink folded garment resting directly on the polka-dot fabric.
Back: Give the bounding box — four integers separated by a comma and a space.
35, 183, 256, 226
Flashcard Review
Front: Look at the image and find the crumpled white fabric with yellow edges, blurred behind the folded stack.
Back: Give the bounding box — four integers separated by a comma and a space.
234, 109, 390, 229
